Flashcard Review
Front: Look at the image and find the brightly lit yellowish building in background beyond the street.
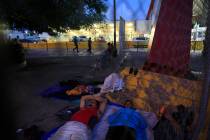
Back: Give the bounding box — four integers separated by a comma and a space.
65, 20, 152, 41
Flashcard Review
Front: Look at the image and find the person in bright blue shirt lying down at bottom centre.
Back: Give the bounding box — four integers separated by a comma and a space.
106, 101, 158, 140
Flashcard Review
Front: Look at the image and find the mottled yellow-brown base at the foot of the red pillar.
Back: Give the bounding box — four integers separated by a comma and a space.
106, 68, 202, 112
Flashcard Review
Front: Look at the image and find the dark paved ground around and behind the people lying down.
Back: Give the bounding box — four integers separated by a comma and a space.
5, 49, 203, 139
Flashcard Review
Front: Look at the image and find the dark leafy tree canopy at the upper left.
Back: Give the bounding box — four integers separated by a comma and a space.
0, 0, 107, 32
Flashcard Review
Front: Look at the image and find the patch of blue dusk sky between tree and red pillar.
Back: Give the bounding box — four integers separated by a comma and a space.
106, 0, 150, 21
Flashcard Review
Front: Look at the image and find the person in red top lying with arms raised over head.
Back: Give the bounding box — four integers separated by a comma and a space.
49, 95, 107, 140
